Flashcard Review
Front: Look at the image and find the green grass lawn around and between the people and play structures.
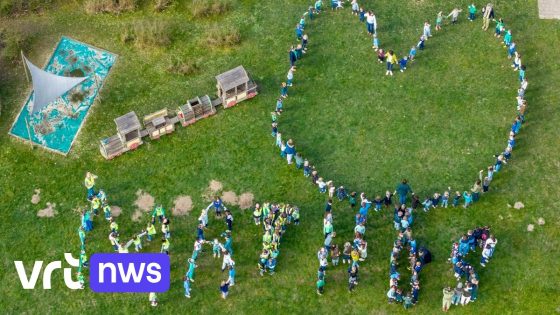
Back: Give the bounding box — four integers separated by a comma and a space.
0, 0, 560, 314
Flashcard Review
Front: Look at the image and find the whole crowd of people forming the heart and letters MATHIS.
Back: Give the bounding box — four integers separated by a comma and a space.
71, 0, 528, 311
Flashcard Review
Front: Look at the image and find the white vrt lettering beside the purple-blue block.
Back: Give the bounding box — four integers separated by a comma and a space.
14, 253, 82, 290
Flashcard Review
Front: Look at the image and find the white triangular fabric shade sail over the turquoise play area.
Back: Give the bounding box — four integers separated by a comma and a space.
23, 56, 87, 114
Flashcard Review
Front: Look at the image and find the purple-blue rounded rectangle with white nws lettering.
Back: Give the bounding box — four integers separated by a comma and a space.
90, 253, 170, 293
